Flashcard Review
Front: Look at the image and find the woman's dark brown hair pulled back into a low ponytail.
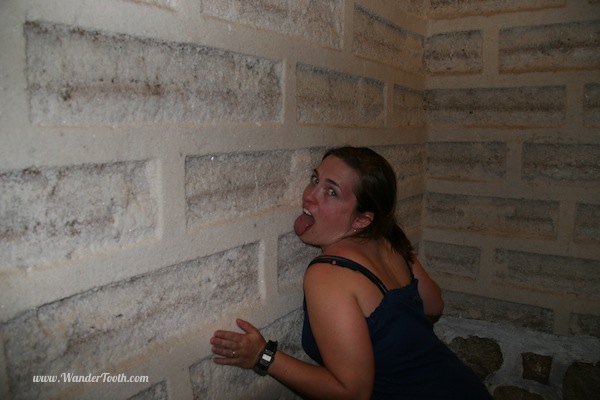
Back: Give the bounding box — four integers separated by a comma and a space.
323, 147, 414, 260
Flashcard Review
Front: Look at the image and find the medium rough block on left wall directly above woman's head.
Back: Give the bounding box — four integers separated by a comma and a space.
296, 64, 385, 126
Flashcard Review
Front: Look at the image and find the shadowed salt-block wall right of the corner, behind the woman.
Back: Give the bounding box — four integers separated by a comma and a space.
421, 0, 600, 346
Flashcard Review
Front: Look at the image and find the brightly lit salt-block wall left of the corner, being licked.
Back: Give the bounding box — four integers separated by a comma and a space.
0, 0, 427, 399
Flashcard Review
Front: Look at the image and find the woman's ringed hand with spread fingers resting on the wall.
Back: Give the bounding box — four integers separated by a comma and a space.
210, 319, 267, 368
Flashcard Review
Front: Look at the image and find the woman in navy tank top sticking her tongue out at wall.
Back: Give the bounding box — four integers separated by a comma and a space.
211, 147, 491, 400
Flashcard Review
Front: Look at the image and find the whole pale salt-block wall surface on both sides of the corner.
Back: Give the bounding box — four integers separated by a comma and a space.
0, 0, 600, 400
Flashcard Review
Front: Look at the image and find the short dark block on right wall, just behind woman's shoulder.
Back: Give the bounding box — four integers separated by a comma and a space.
421, 241, 481, 279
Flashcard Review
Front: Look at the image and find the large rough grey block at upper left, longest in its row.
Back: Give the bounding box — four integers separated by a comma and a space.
25, 22, 283, 125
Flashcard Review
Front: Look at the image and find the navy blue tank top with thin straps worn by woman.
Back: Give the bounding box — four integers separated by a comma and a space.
302, 256, 492, 400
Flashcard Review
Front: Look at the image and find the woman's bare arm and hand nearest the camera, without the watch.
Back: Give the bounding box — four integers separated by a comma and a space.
211, 264, 374, 400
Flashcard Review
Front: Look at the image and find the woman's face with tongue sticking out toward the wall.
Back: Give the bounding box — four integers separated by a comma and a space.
294, 156, 359, 250
